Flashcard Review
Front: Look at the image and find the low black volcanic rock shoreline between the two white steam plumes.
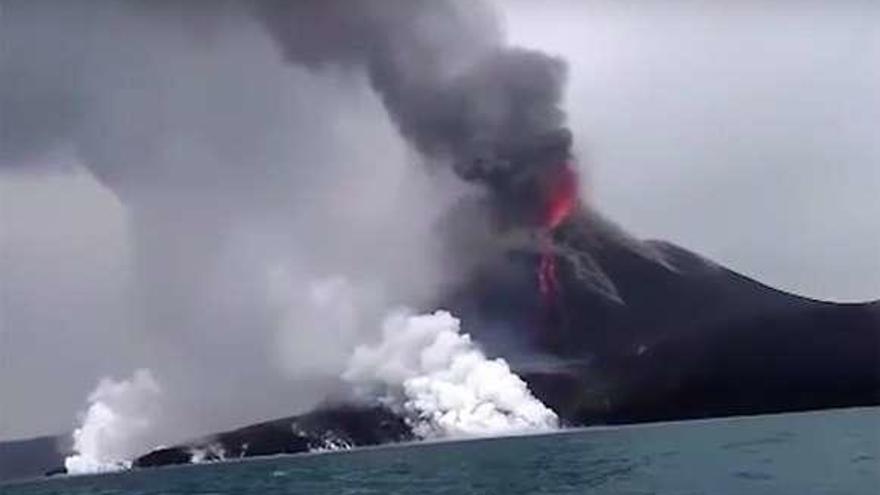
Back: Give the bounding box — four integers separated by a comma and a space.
133, 404, 414, 468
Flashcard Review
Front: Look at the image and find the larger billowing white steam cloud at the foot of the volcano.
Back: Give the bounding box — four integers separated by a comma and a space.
344, 311, 558, 438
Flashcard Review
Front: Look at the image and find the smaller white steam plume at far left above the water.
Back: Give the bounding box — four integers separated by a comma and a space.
64, 369, 162, 474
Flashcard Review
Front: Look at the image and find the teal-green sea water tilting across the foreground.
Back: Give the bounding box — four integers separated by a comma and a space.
0, 408, 880, 495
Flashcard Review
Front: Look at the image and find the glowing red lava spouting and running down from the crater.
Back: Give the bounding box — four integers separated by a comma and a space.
538, 163, 578, 304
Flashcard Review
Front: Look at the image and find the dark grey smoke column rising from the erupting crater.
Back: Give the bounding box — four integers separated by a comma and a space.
256, 0, 572, 226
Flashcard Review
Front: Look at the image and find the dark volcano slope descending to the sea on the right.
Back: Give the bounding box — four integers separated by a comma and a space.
448, 210, 880, 425
